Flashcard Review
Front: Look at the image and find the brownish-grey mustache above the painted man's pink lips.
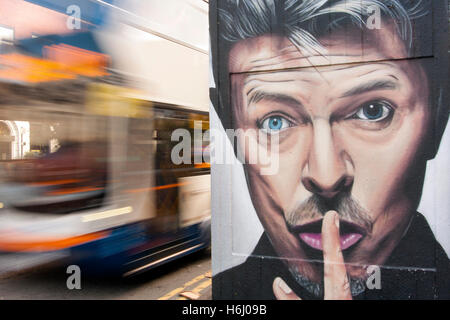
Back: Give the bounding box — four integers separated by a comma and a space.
286, 193, 373, 234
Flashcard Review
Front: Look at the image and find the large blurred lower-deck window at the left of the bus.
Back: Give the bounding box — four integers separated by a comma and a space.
0, 103, 108, 213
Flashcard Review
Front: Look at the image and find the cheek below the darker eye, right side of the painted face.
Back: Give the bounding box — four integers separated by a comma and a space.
341, 112, 426, 216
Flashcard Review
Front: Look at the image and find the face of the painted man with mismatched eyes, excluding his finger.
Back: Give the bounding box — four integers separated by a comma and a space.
229, 31, 430, 282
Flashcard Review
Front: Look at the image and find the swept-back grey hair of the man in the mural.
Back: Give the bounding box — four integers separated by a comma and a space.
219, 0, 428, 55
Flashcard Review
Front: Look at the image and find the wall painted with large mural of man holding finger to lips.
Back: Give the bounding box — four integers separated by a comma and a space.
210, 0, 450, 299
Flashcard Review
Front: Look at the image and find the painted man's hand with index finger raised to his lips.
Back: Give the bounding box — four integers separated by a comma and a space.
272, 211, 352, 300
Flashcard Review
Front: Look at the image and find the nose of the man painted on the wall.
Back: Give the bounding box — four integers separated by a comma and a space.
302, 119, 354, 198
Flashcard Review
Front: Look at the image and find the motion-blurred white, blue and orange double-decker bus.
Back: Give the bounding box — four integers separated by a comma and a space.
0, 0, 210, 276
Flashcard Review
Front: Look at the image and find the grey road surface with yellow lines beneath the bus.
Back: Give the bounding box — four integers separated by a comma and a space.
0, 251, 211, 300
